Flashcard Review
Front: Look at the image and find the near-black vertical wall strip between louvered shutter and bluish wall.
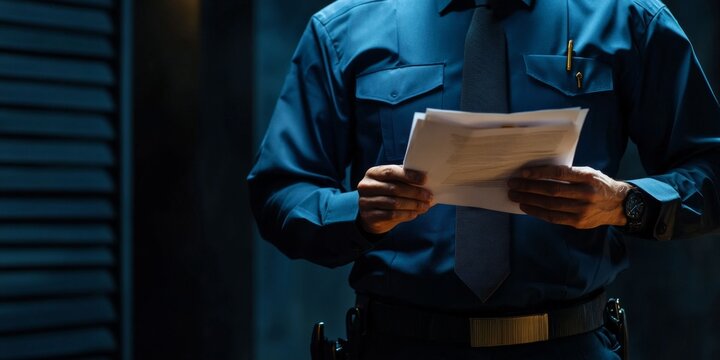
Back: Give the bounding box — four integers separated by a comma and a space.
134, 0, 253, 360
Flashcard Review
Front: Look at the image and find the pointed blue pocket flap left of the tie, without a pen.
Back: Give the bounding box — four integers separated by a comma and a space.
355, 64, 445, 105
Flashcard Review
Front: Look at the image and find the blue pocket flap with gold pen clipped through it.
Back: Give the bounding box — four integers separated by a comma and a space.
525, 55, 613, 96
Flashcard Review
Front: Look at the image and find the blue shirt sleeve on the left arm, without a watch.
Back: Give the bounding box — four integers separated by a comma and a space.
248, 18, 371, 267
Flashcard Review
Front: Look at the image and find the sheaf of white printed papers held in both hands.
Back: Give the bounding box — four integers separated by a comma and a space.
403, 108, 588, 214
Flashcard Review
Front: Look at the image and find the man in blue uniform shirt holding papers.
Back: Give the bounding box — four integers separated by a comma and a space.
248, 0, 720, 359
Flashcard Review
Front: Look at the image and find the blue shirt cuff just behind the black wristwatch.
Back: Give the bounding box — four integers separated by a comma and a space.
627, 178, 680, 241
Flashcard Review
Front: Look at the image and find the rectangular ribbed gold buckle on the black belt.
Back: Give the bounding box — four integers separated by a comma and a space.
470, 314, 550, 347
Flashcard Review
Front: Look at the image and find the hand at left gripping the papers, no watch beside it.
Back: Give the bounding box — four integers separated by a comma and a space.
358, 165, 433, 234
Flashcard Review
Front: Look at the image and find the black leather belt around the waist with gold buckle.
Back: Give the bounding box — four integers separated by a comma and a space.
366, 292, 607, 347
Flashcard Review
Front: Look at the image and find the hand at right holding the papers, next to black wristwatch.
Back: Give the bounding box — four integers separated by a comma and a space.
508, 165, 632, 229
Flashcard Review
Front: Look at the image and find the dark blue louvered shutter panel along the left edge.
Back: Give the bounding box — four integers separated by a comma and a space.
0, 0, 129, 360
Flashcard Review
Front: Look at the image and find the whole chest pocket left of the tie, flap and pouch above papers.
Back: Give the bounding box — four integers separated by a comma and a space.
355, 64, 444, 163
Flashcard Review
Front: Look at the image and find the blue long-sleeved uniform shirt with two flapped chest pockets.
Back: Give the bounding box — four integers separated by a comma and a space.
248, 0, 720, 311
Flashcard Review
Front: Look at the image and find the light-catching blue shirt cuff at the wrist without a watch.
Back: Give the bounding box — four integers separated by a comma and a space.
325, 191, 379, 254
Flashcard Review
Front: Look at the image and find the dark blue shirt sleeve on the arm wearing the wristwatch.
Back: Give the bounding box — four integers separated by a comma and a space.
629, 8, 720, 240
